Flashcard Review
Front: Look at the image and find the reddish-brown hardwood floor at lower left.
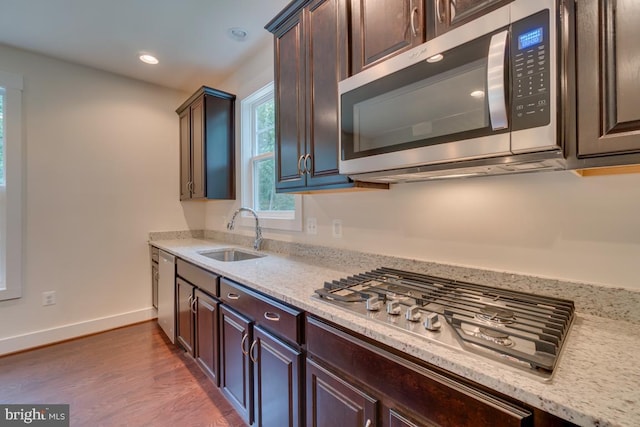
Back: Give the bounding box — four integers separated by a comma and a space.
0, 322, 245, 427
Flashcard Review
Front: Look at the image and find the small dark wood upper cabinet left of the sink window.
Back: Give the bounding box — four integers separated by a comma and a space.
176, 86, 236, 200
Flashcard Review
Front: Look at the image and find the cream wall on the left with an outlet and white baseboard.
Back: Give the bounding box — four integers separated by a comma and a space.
0, 45, 204, 354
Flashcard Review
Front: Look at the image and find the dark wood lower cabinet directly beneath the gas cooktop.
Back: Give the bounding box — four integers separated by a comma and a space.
305, 316, 571, 427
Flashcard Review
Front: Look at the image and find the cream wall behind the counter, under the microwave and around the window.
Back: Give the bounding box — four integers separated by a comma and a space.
206, 38, 640, 289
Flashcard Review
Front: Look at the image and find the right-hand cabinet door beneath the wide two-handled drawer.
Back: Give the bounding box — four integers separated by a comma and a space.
251, 326, 303, 427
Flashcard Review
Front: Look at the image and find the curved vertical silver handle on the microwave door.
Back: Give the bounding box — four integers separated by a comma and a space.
487, 31, 509, 130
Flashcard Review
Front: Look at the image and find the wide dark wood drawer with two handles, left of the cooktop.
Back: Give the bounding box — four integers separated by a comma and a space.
220, 278, 303, 344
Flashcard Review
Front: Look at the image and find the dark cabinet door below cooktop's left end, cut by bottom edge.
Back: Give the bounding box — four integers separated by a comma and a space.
306, 359, 378, 427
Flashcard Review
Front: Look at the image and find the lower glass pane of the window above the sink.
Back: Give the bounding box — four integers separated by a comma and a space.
253, 157, 295, 211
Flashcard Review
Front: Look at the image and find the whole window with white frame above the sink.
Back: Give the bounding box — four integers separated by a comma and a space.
240, 83, 302, 230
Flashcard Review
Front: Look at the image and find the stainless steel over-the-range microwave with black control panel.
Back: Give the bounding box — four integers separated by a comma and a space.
339, 0, 568, 183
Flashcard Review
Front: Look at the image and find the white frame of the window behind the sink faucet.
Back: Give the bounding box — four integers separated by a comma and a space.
240, 82, 302, 231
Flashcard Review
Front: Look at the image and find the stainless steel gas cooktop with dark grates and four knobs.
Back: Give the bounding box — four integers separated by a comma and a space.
313, 268, 575, 380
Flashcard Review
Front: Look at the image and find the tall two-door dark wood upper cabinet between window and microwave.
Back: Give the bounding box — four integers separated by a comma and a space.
266, 0, 384, 192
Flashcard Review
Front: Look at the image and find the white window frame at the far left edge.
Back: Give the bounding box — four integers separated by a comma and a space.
0, 71, 24, 300
